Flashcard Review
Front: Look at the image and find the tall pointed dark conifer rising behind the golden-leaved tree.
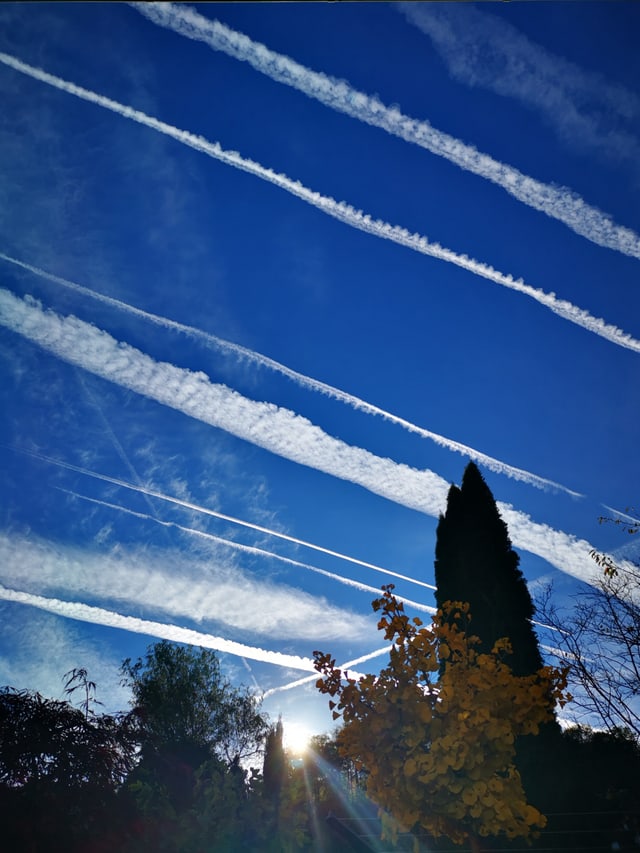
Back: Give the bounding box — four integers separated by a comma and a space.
435, 462, 542, 675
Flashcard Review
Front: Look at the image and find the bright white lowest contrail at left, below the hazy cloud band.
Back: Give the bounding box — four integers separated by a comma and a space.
0, 584, 314, 672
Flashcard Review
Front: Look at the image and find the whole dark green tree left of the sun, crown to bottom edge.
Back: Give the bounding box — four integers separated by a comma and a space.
119, 641, 268, 853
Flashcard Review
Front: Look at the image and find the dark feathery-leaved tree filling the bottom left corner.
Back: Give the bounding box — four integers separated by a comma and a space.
0, 687, 137, 853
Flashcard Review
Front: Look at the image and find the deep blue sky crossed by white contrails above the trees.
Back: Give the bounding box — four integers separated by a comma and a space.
0, 3, 640, 744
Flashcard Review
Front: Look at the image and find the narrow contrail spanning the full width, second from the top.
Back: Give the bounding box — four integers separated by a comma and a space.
0, 52, 640, 352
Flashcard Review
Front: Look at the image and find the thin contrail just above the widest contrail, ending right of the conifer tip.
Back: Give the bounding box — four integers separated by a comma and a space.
0, 252, 583, 498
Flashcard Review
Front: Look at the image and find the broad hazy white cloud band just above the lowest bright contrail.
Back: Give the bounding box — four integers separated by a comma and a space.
0, 533, 371, 641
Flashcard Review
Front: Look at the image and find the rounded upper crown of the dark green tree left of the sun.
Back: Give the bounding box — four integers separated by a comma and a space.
122, 640, 267, 764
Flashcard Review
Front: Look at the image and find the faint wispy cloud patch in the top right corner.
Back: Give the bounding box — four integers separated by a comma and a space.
400, 3, 640, 175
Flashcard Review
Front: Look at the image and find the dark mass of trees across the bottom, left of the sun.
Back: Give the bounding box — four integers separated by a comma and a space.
0, 642, 296, 853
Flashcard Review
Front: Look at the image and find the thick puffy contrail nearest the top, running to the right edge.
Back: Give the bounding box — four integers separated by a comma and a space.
130, 3, 640, 258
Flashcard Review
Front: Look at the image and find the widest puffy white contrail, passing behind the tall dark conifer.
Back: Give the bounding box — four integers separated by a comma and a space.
0, 289, 624, 583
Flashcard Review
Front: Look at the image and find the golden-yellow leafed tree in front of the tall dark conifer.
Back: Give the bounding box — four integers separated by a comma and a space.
314, 586, 565, 849
